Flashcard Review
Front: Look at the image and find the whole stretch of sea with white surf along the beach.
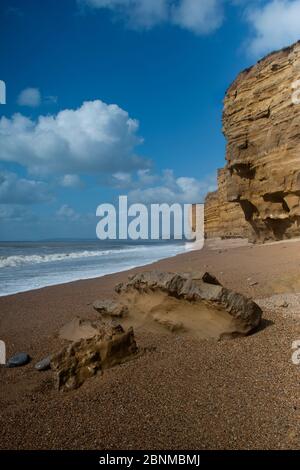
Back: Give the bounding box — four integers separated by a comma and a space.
0, 240, 191, 296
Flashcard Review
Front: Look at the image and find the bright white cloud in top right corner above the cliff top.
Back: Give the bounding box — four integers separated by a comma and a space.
246, 0, 300, 56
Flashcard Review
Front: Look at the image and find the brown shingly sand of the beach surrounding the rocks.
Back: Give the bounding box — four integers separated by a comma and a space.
0, 240, 300, 450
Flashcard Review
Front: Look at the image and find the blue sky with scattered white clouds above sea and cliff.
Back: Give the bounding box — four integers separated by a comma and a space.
0, 0, 300, 240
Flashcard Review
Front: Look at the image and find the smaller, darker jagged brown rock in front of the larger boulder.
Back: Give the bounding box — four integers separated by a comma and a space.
51, 323, 137, 391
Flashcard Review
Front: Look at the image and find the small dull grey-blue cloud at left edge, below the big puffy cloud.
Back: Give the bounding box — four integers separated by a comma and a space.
0, 171, 52, 204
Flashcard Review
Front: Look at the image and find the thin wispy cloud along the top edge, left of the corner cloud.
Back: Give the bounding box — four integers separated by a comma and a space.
78, 0, 223, 34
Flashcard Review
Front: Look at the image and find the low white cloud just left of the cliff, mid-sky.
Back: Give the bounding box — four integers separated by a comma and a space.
128, 170, 216, 204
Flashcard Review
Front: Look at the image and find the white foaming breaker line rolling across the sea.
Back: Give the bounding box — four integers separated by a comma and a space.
0, 247, 146, 269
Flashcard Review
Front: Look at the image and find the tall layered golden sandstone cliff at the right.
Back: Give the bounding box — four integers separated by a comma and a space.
205, 43, 300, 241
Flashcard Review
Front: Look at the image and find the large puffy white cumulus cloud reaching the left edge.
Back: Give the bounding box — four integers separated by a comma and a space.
0, 100, 150, 174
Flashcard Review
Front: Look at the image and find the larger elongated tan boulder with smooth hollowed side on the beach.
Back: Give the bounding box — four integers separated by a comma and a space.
115, 271, 262, 339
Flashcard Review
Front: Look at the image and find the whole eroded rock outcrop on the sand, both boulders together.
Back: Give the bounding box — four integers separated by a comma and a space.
51, 271, 262, 391
